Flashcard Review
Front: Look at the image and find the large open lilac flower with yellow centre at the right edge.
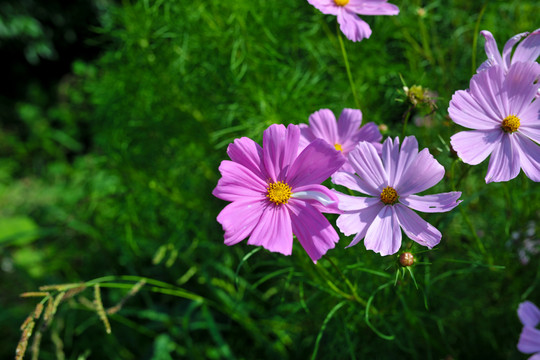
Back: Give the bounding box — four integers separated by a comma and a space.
448, 62, 540, 183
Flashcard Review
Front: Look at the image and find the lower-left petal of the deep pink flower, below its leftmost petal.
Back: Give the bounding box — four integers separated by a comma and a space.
217, 200, 266, 246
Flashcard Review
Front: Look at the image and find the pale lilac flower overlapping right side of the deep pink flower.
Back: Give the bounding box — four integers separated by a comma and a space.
332, 136, 461, 255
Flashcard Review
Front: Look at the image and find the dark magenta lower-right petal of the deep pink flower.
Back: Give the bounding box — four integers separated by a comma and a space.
290, 201, 339, 262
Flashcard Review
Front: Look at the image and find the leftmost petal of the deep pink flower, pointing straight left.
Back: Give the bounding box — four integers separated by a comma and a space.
212, 160, 267, 201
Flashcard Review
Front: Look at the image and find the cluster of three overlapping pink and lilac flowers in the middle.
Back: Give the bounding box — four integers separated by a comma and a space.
213, 116, 461, 262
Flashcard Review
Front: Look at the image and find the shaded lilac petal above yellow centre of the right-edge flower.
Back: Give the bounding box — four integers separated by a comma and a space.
503, 62, 540, 114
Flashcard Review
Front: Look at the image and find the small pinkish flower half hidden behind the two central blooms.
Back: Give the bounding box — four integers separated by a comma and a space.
299, 109, 382, 172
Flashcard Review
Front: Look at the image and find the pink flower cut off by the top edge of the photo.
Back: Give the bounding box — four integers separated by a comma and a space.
308, 0, 399, 41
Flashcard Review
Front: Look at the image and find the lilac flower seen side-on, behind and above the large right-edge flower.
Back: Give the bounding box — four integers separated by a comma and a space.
477, 29, 540, 73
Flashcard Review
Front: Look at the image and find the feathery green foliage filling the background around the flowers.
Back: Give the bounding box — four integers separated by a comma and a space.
0, 0, 540, 359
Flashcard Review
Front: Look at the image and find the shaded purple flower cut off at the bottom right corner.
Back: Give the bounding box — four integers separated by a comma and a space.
518, 301, 540, 360
